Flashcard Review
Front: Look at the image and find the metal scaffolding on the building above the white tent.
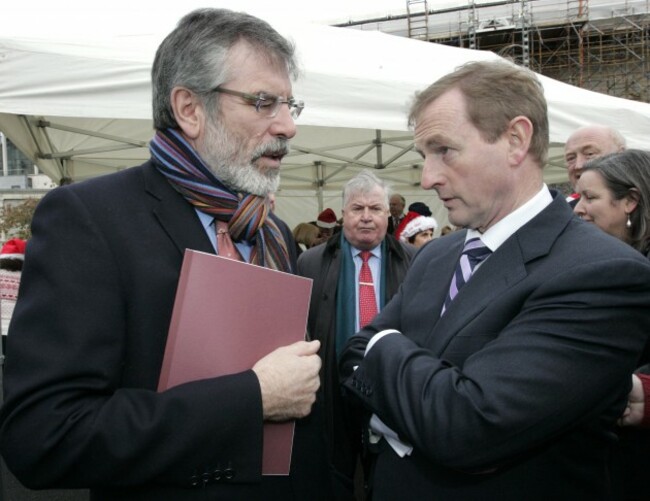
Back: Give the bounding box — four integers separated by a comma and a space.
338, 0, 650, 102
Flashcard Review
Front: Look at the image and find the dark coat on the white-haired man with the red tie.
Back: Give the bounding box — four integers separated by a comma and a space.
298, 234, 415, 494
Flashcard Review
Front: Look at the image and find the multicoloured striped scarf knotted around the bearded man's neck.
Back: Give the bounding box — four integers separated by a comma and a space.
149, 129, 291, 272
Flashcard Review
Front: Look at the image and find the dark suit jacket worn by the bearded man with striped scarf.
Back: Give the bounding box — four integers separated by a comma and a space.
0, 163, 329, 500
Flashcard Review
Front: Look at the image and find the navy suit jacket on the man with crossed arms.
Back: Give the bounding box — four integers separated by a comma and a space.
341, 195, 650, 501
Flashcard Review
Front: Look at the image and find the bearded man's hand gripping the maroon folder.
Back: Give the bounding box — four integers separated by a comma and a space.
253, 341, 321, 421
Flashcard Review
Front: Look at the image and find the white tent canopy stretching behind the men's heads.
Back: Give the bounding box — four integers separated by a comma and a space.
0, 12, 650, 226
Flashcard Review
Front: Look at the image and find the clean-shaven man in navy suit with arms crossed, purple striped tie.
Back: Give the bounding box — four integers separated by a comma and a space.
340, 61, 650, 501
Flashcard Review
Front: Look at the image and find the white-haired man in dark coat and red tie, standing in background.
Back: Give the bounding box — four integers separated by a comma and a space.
298, 171, 415, 499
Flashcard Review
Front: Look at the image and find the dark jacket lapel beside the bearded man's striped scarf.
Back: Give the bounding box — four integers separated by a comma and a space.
144, 162, 214, 254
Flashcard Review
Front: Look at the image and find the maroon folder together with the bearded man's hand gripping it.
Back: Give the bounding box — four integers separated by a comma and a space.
158, 249, 321, 475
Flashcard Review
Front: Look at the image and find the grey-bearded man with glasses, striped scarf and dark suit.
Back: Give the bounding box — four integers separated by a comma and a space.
0, 9, 330, 501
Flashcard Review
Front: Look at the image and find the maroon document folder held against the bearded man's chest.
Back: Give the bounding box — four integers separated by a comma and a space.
158, 249, 312, 475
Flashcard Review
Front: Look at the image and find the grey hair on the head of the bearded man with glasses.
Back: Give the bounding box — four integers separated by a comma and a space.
151, 9, 299, 130
